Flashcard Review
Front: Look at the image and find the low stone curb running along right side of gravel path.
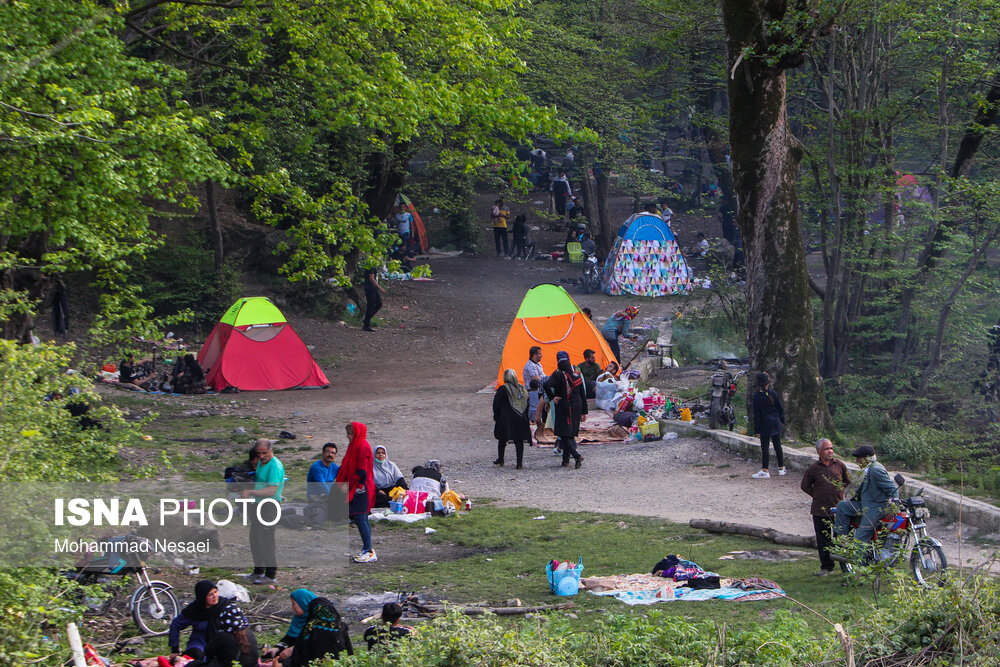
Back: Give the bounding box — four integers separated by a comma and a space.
670, 420, 1000, 533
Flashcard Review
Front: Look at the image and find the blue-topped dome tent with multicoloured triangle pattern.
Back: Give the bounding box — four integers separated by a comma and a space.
603, 213, 691, 296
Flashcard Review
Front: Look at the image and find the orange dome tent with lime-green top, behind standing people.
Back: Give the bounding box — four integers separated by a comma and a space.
497, 283, 615, 387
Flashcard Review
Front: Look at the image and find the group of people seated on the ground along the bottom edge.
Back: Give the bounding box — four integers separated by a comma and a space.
155, 580, 413, 667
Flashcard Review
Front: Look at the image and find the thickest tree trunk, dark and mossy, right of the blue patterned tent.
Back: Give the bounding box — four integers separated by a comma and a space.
722, 0, 833, 436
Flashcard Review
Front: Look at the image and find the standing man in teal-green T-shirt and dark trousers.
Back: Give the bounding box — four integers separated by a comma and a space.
240, 438, 285, 584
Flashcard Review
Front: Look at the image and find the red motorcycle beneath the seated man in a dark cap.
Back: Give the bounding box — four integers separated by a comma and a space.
831, 474, 948, 587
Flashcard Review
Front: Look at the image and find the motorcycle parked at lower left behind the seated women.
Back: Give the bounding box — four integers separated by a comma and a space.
63, 535, 180, 635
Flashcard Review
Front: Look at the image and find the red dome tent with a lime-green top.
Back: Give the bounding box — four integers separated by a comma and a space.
198, 296, 330, 391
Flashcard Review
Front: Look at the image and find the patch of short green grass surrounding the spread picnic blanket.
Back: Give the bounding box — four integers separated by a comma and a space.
344, 503, 869, 632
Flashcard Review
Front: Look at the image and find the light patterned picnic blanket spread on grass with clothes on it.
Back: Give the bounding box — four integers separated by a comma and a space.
580, 574, 785, 605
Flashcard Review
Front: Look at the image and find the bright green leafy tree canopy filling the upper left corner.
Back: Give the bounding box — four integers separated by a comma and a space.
0, 0, 226, 334
